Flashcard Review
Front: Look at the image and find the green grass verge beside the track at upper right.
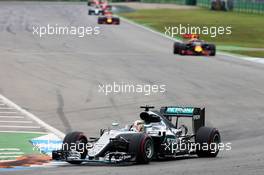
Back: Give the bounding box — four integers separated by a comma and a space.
120, 9, 264, 57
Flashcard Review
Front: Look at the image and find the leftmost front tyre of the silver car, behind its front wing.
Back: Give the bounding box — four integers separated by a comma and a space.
62, 131, 88, 164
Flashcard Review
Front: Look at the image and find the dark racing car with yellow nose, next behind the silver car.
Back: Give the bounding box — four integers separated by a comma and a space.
173, 34, 216, 56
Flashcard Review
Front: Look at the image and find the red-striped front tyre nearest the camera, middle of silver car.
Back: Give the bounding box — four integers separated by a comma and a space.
126, 133, 154, 164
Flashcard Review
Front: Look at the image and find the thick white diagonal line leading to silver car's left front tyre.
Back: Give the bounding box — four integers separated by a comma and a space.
0, 95, 65, 139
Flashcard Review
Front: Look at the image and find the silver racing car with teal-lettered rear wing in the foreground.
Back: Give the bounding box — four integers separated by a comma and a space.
52, 106, 221, 164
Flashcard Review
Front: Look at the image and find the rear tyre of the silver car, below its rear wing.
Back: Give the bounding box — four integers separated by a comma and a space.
195, 127, 221, 157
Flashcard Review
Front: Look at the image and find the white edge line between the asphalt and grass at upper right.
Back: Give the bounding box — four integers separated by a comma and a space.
119, 16, 264, 64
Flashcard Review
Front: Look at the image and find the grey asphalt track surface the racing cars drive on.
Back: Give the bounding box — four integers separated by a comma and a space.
0, 2, 264, 175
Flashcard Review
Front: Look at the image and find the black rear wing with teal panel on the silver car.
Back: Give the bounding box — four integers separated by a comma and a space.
160, 106, 205, 134
